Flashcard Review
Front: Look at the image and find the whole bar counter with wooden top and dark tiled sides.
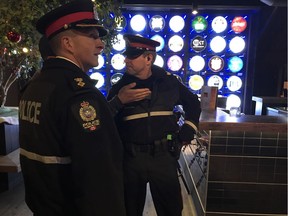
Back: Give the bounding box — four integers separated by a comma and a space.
179, 109, 287, 216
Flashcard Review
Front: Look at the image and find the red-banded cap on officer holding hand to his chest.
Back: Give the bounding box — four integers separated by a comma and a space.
123, 34, 160, 59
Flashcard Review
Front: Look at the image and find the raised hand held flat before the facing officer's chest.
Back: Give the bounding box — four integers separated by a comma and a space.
118, 82, 151, 104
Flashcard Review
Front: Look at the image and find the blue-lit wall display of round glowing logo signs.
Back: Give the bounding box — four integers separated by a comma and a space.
90, 9, 250, 109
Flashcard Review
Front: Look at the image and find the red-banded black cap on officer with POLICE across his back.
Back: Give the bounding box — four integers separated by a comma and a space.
36, 0, 107, 39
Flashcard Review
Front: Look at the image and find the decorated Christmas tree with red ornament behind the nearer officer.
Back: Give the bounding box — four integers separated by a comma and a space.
0, 0, 121, 107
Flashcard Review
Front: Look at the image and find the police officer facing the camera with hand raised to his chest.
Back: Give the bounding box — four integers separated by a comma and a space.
107, 34, 201, 216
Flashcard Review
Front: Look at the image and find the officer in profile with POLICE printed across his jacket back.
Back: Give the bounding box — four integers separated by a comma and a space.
19, 0, 126, 216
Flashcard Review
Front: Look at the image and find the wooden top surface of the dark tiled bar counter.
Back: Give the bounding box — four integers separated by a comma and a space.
199, 109, 287, 133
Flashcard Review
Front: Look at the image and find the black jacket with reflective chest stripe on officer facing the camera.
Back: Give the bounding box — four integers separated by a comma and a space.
107, 66, 201, 144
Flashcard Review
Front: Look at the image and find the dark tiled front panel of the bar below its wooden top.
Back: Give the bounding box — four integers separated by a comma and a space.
183, 131, 287, 215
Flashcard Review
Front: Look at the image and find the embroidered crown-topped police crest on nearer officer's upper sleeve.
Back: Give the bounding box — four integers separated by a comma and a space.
79, 101, 100, 131
